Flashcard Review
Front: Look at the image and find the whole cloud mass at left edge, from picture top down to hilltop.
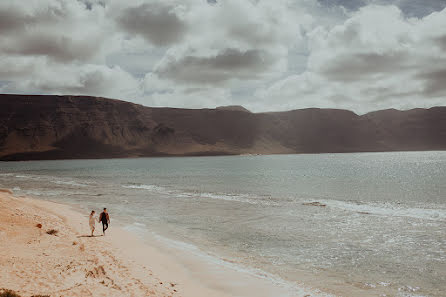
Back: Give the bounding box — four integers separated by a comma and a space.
0, 0, 139, 98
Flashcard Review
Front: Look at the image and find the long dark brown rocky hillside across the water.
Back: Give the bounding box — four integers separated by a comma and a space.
0, 95, 446, 160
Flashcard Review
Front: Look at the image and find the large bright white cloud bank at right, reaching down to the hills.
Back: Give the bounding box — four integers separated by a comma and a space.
257, 5, 446, 112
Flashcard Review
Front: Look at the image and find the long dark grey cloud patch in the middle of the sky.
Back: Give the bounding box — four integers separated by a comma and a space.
156, 49, 276, 83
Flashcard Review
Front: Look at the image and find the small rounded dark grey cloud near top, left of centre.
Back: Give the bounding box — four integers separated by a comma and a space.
117, 3, 186, 46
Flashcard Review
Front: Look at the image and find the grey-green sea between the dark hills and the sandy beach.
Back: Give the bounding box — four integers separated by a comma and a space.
0, 152, 446, 297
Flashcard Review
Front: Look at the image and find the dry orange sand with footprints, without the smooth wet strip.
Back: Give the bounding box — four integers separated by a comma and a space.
0, 190, 235, 296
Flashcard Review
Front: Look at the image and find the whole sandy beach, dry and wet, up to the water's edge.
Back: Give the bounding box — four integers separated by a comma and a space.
0, 190, 331, 297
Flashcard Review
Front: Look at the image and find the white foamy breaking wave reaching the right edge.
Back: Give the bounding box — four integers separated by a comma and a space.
321, 200, 446, 221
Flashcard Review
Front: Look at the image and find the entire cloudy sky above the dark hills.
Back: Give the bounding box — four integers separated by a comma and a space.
0, 0, 446, 113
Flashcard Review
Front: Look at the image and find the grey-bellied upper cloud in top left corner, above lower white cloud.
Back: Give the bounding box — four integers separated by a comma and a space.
0, 3, 104, 63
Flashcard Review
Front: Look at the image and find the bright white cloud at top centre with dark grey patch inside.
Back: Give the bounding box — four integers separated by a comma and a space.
136, 0, 311, 88
